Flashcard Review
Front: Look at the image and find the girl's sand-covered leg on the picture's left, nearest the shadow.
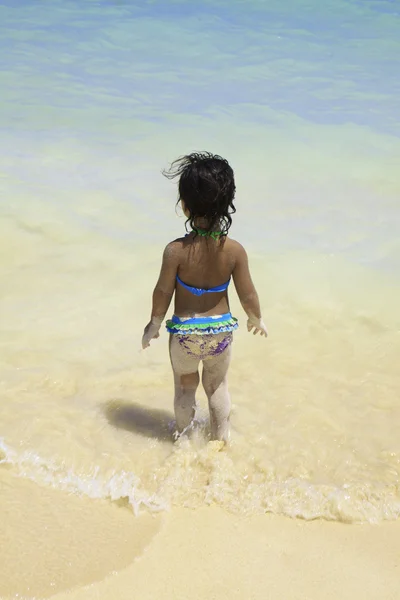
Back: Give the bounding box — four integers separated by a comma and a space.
169, 334, 200, 433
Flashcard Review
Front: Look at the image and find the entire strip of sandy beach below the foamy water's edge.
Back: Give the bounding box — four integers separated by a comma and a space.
0, 480, 400, 600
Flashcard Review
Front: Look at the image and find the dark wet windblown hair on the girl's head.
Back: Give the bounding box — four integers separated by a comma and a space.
163, 152, 236, 235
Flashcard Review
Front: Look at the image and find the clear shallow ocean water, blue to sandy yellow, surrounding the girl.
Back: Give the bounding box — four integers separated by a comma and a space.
0, 0, 400, 544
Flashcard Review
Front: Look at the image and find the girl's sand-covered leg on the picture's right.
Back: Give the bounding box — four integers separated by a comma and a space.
202, 343, 232, 442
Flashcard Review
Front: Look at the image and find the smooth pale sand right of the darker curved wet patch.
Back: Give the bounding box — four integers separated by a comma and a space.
50, 507, 400, 600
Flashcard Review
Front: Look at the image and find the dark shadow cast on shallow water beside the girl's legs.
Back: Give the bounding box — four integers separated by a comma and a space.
104, 399, 174, 443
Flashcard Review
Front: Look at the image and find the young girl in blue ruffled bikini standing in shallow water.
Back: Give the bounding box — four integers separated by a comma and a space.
142, 153, 267, 442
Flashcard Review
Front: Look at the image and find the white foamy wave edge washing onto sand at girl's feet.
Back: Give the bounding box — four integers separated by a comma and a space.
0, 439, 400, 523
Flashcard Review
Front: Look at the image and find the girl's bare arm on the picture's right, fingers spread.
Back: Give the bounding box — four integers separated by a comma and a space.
232, 242, 268, 337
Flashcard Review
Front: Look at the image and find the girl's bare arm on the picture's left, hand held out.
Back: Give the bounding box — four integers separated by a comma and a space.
142, 242, 179, 349
